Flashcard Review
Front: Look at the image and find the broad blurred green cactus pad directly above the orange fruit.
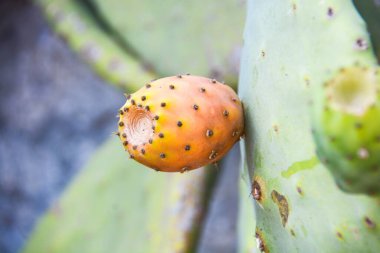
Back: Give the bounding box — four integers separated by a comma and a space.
88, 0, 245, 84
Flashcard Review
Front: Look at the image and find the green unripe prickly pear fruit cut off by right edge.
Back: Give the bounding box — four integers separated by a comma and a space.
313, 66, 380, 194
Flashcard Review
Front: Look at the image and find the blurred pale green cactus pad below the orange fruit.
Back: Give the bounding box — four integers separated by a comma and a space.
23, 137, 215, 253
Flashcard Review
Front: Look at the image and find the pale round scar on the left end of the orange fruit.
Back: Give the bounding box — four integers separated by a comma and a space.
119, 106, 153, 146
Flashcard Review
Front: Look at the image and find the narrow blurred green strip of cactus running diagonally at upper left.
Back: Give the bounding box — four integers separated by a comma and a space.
36, 0, 156, 91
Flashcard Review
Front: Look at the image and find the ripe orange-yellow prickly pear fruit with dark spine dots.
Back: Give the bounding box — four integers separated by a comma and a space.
117, 75, 244, 172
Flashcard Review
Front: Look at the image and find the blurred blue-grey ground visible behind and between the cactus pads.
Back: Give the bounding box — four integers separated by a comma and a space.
0, 0, 237, 253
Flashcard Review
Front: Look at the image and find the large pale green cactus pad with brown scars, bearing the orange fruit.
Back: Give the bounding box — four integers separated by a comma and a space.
239, 0, 380, 253
